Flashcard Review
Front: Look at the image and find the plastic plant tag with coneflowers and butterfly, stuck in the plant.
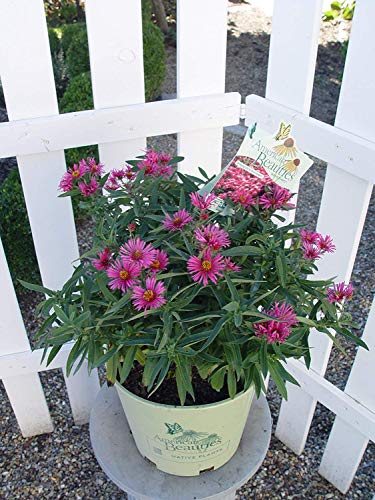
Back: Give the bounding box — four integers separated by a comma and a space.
201, 123, 313, 215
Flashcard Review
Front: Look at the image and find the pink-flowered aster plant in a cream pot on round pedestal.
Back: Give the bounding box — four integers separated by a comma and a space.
23, 150, 366, 475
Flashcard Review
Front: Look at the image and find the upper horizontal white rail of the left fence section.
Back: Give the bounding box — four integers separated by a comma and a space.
0, 92, 241, 158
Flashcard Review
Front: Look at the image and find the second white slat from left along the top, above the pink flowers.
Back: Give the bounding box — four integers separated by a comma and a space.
85, 0, 146, 170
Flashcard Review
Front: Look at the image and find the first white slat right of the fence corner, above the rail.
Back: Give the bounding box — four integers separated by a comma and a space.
266, 0, 322, 114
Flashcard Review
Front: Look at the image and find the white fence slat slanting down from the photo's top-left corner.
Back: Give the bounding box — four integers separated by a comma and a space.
0, 0, 99, 430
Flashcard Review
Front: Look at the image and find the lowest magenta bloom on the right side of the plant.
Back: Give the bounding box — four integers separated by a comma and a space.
253, 302, 298, 344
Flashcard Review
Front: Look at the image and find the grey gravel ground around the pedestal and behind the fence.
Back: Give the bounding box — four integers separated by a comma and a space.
0, 6, 375, 500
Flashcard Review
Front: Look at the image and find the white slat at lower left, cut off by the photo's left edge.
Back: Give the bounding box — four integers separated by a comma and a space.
0, 236, 53, 437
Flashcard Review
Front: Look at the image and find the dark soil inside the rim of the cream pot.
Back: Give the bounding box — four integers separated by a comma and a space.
122, 363, 243, 406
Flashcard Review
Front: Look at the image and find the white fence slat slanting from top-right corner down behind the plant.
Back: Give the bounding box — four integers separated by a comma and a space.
276, 2, 375, 468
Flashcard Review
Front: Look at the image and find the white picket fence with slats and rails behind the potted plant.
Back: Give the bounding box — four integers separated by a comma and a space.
0, 0, 375, 492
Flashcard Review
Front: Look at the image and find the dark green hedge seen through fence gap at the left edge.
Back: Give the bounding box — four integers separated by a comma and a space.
0, 168, 40, 292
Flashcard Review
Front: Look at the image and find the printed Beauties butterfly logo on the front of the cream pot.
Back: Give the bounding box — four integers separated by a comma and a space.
149, 422, 229, 462
